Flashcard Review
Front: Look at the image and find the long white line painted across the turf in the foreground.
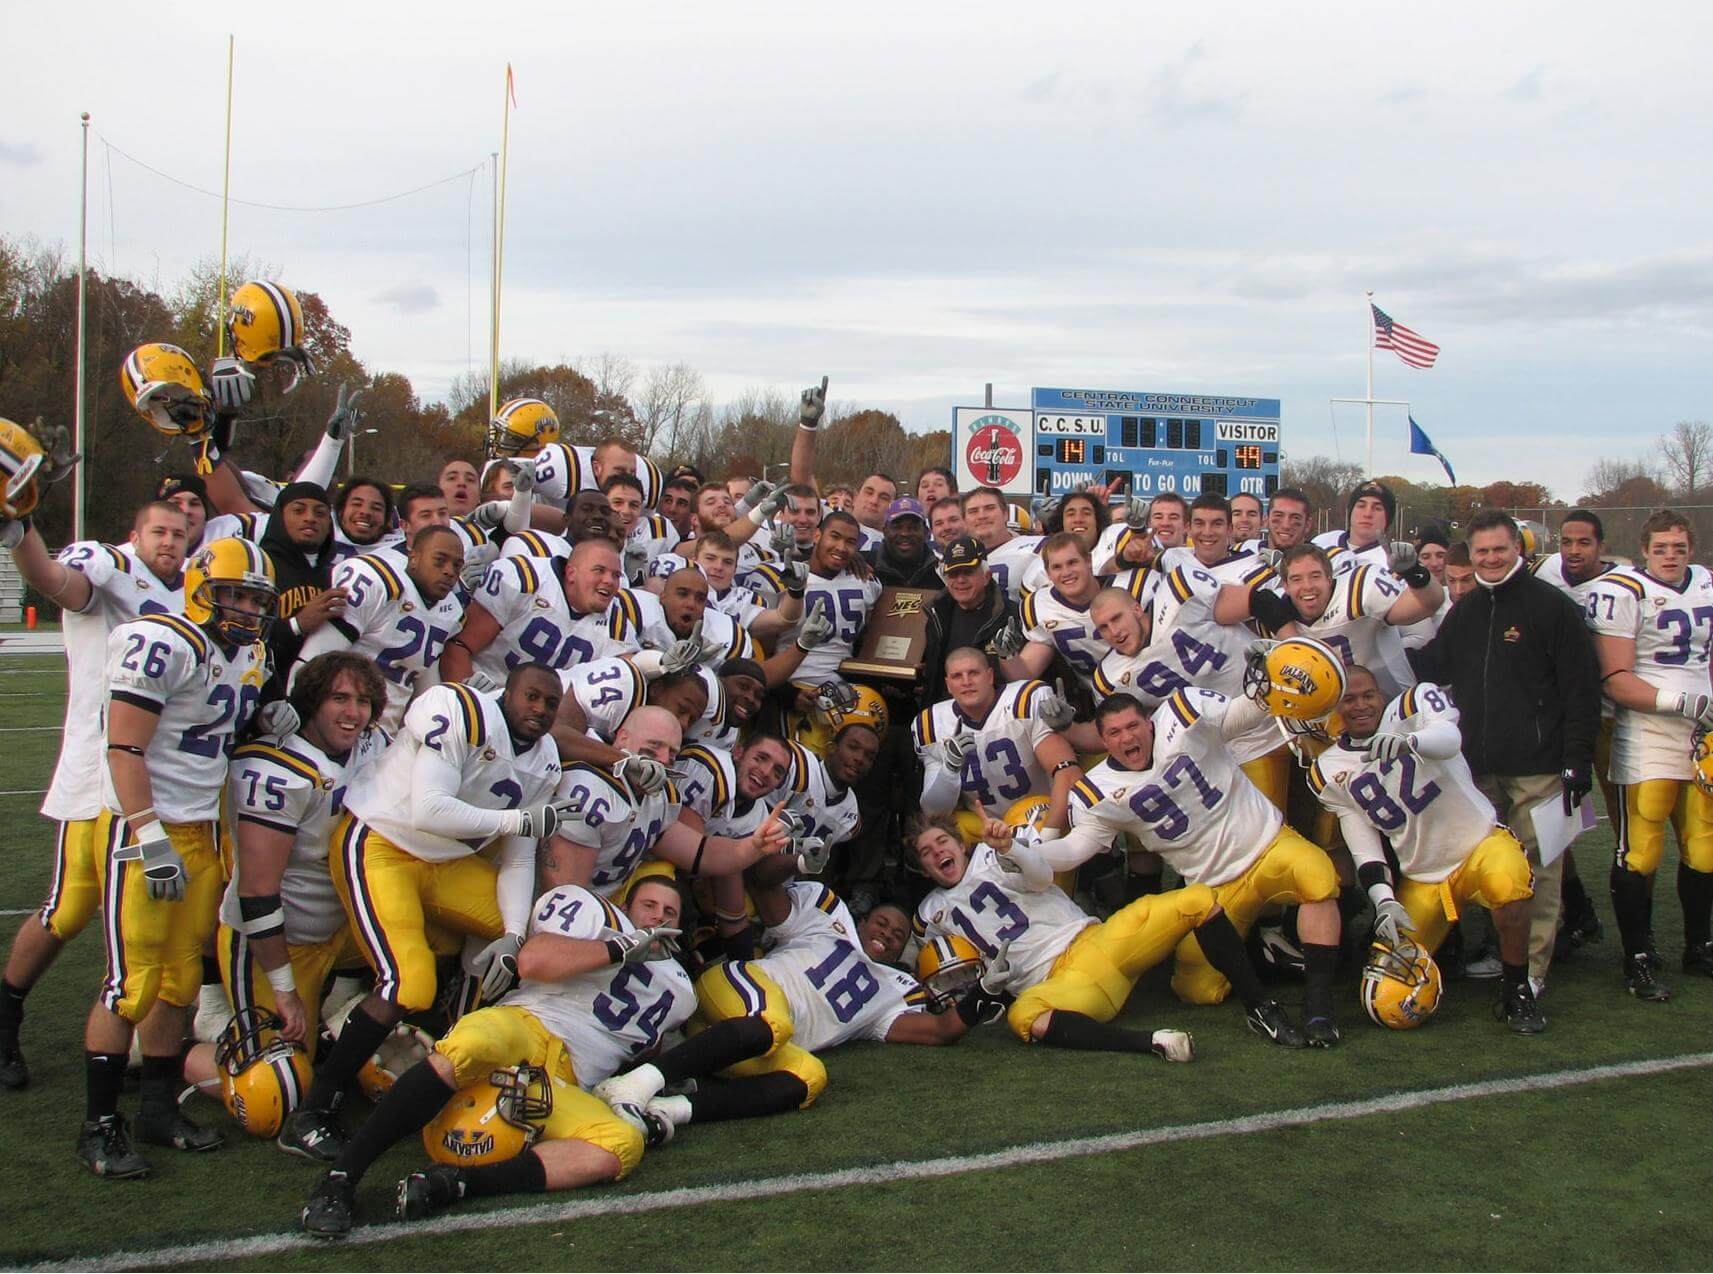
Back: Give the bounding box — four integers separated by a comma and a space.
29, 1053, 1713, 1269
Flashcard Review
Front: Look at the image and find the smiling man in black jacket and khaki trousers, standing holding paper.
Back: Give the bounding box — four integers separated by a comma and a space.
1412, 510, 1600, 993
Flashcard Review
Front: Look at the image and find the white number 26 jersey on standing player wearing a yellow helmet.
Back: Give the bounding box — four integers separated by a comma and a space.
101, 615, 269, 824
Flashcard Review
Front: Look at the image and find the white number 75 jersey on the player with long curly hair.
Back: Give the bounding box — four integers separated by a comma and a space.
219, 729, 391, 945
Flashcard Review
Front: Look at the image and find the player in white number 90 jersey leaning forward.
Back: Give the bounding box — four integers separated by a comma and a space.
440, 538, 641, 682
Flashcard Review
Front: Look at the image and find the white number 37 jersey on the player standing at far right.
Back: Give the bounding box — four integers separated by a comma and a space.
1586, 565, 1713, 784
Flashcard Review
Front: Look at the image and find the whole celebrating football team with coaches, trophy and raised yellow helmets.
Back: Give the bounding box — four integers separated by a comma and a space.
0, 281, 1713, 1236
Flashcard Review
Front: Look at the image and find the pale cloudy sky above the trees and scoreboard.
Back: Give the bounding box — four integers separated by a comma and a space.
0, 0, 1713, 498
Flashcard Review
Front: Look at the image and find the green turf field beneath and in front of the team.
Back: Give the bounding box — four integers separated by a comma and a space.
0, 658, 1713, 1271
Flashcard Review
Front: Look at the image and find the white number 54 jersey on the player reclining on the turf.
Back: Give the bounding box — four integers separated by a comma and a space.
500, 885, 695, 1089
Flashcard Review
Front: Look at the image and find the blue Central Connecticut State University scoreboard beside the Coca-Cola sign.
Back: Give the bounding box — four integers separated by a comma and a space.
1031, 389, 1280, 500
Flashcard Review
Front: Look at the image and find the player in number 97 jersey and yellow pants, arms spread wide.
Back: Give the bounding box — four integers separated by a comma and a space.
1042, 688, 1340, 1048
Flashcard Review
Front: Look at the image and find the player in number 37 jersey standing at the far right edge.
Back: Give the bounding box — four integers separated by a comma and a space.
1586, 509, 1713, 1002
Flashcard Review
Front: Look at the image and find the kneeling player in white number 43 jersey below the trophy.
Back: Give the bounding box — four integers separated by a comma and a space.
911, 646, 1079, 827
